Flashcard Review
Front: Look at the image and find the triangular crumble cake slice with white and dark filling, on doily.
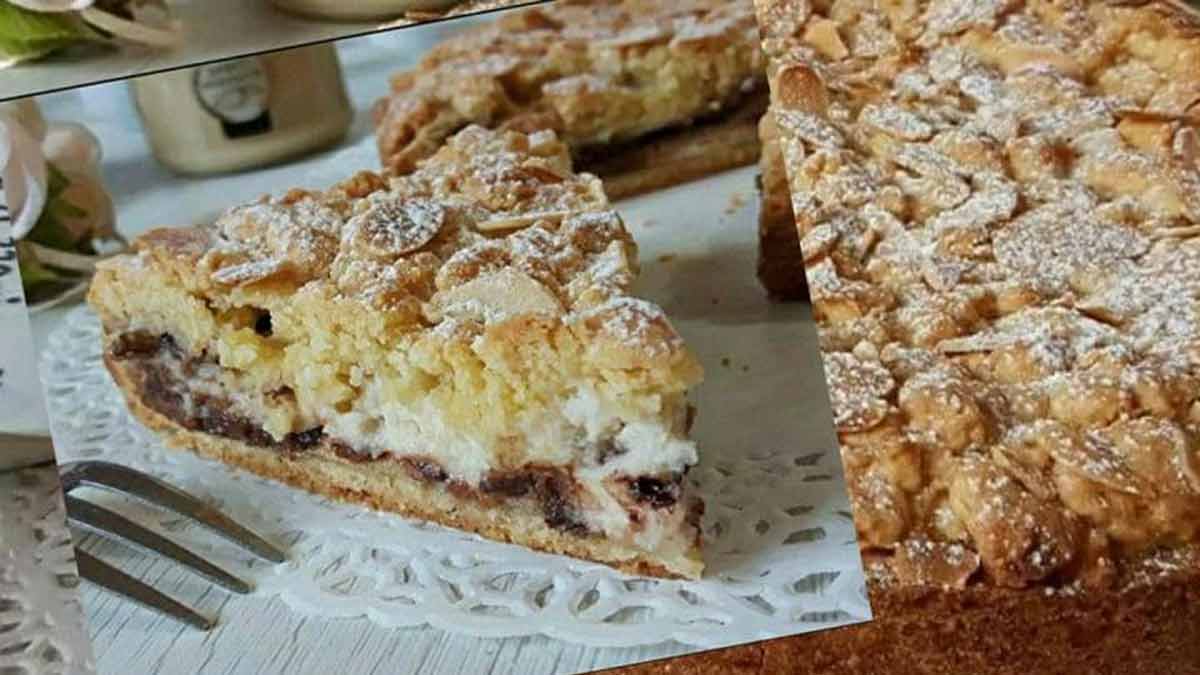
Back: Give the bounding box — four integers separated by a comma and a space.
89, 126, 703, 578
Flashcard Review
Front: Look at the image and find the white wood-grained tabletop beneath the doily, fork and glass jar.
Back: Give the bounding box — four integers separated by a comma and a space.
16, 26, 695, 675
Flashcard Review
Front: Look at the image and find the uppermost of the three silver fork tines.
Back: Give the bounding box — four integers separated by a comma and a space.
61, 461, 287, 562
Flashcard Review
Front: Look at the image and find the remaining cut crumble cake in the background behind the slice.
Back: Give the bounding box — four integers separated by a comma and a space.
376, 0, 764, 197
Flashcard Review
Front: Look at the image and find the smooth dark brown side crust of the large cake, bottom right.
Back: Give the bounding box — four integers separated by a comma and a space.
606, 569, 1200, 675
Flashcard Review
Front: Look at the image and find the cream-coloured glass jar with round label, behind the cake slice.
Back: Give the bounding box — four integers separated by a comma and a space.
132, 43, 354, 174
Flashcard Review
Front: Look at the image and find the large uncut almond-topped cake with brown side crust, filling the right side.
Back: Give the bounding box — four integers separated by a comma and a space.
696, 0, 1200, 674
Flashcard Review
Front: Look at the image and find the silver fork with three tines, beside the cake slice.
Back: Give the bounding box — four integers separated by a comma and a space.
59, 460, 287, 631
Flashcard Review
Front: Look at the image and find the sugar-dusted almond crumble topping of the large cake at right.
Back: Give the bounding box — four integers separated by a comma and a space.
768, 0, 1200, 583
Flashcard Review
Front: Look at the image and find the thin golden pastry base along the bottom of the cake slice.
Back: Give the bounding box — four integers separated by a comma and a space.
104, 354, 703, 579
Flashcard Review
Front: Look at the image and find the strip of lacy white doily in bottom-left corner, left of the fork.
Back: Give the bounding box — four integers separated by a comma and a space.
0, 467, 95, 675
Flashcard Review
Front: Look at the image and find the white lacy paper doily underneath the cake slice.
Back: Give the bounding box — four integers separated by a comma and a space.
42, 162, 870, 647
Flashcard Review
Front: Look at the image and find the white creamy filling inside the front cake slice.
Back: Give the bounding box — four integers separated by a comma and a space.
139, 341, 697, 555
